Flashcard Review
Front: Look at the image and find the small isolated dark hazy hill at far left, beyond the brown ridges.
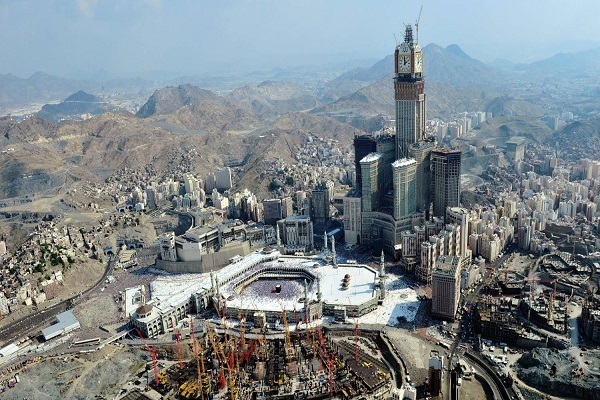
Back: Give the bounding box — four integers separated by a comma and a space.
37, 90, 116, 121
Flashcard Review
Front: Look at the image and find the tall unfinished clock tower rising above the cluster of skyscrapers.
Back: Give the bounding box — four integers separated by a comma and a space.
394, 25, 425, 160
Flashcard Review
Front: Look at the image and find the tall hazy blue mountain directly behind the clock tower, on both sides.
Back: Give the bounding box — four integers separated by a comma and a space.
311, 43, 512, 128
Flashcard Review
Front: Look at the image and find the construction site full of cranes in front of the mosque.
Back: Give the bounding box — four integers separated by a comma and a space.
130, 312, 402, 400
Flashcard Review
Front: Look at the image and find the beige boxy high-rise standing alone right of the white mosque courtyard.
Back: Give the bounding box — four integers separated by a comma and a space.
431, 256, 461, 320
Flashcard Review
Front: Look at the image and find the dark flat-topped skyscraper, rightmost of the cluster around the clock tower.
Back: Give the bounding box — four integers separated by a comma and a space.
431, 149, 462, 219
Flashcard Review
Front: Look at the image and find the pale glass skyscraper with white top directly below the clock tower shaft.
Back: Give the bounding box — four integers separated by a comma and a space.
392, 158, 417, 219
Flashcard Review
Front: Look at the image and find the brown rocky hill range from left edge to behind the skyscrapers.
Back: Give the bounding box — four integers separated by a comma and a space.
0, 87, 364, 198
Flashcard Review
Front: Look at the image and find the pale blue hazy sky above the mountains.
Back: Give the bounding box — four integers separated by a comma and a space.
0, 0, 600, 77
